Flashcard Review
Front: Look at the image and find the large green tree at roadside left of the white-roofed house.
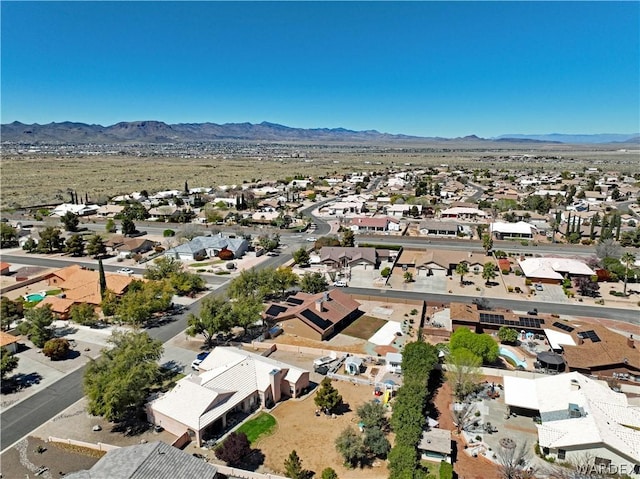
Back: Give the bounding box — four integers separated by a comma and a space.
84, 332, 162, 421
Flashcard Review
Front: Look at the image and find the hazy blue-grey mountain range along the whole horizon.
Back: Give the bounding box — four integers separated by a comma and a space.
0, 121, 640, 144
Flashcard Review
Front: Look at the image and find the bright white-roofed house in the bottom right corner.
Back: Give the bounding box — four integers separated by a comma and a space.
504, 372, 640, 477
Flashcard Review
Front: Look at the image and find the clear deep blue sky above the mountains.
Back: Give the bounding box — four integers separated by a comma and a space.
0, 1, 640, 137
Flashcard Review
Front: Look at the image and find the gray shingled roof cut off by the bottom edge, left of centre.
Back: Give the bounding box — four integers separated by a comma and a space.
65, 442, 218, 479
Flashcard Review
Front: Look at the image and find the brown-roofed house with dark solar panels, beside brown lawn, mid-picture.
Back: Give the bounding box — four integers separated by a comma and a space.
263, 288, 361, 341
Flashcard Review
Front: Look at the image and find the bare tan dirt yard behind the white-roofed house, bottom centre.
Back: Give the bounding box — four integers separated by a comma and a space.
256, 381, 393, 479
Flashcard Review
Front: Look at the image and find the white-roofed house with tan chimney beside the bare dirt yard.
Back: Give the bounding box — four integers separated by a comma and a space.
146, 347, 309, 445
